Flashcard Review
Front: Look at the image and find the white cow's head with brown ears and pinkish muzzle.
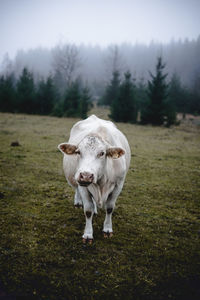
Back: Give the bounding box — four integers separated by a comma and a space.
58, 135, 125, 186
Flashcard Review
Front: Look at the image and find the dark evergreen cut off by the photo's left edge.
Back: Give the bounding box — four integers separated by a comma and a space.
0, 74, 16, 112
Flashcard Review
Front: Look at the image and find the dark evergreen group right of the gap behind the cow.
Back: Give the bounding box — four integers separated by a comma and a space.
99, 56, 200, 126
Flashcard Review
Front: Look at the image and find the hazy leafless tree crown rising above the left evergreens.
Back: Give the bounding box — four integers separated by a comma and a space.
53, 44, 81, 87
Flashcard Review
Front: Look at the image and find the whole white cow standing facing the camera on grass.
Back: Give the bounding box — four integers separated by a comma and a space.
58, 115, 131, 244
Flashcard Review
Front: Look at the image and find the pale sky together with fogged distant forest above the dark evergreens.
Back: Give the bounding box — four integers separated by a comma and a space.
0, 0, 200, 95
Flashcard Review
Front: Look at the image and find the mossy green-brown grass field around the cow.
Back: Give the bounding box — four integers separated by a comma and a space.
0, 110, 200, 300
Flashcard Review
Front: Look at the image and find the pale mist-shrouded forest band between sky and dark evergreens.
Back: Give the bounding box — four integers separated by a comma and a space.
1, 36, 200, 93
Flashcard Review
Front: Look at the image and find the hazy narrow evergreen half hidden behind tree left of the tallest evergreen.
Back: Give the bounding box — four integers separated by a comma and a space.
99, 71, 120, 106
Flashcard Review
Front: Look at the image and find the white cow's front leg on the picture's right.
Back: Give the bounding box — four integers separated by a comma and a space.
103, 180, 124, 238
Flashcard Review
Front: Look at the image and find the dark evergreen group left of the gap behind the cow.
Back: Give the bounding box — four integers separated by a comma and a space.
0, 68, 91, 119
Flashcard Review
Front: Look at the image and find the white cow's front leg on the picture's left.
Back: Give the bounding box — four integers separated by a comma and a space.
78, 186, 95, 244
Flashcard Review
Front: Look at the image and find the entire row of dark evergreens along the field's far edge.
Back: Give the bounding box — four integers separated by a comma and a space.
0, 56, 200, 126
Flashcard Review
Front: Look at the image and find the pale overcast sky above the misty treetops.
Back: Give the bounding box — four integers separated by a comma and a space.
0, 0, 200, 61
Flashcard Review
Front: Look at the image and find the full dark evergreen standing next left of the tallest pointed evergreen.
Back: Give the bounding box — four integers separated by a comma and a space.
110, 72, 137, 123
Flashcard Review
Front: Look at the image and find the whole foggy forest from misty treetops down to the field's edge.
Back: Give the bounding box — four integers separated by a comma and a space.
0, 36, 200, 125
